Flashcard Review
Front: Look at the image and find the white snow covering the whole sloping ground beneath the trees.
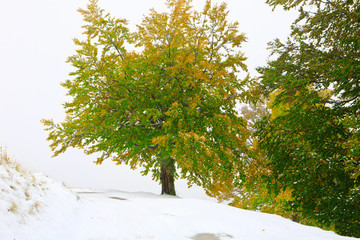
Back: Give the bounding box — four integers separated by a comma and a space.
0, 158, 355, 240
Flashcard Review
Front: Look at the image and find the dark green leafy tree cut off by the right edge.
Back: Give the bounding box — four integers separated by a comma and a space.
258, 0, 360, 237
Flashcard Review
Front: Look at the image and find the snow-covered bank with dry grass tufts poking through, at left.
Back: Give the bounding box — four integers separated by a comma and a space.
0, 155, 79, 240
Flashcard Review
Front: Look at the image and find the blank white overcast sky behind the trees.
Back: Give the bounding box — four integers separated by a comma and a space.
0, 0, 296, 196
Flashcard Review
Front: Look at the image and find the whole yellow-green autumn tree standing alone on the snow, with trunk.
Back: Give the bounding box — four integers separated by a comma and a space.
43, 0, 248, 195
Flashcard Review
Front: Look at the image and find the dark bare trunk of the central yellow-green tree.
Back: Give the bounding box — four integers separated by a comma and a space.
160, 158, 176, 196
